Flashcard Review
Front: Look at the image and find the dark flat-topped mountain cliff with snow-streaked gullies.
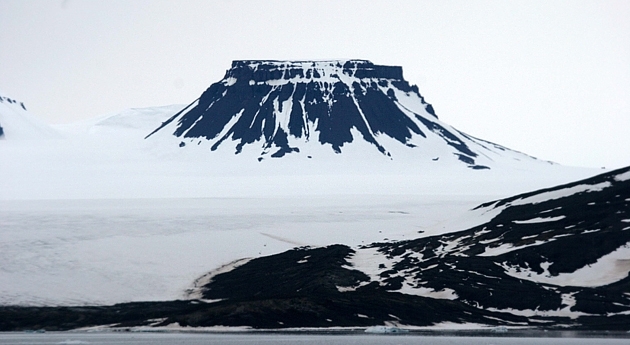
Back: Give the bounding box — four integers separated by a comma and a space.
147, 60, 502, 166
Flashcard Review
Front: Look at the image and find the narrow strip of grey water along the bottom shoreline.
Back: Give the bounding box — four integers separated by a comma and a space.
0, 333, 630, 345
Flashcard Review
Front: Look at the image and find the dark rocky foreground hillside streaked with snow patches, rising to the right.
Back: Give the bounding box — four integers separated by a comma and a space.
188, 168, 630, 329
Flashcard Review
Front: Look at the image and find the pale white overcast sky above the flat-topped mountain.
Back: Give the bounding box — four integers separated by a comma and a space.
0, 0, 630, 168
